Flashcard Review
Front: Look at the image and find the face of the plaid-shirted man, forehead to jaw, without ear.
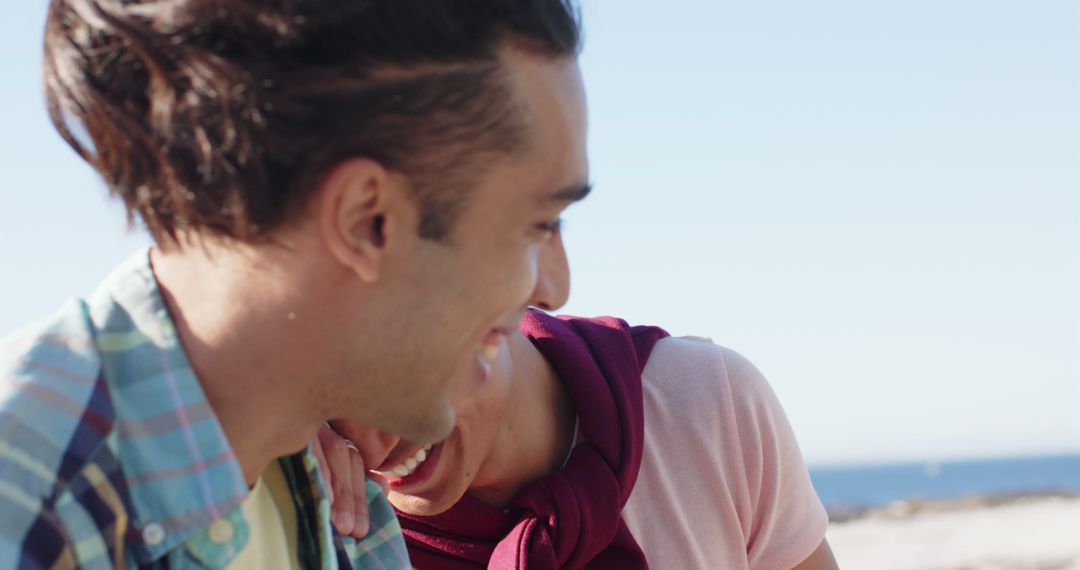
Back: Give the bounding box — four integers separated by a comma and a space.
324, 48, 588, 449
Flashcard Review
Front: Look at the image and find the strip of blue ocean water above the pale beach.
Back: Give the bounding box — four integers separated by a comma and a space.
810, 454, 1080, 511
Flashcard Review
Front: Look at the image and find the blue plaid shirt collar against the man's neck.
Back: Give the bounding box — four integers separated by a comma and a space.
87, 248, 248, 560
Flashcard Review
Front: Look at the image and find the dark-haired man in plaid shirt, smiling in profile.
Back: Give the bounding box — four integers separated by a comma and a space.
0, 0, 589, 568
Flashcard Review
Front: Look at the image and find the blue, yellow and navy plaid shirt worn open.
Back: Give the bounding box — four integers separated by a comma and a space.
0, 250, 409, 569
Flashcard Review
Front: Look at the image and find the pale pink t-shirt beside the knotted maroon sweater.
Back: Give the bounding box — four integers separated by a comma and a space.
622, 338, 828, 570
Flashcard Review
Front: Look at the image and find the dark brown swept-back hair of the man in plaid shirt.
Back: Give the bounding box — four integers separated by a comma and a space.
44, 0, 581, 242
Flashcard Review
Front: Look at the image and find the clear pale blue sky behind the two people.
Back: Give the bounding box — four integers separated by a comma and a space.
0, 0, 1080, 463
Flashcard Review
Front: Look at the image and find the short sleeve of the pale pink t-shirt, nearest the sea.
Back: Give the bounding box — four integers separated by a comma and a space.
717, 347, 828, 570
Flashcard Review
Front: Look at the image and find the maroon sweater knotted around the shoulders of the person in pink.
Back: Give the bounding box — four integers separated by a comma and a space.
397, 311, 667, 570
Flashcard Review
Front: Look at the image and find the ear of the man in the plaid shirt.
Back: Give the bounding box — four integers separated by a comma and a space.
318, 158, 406, 283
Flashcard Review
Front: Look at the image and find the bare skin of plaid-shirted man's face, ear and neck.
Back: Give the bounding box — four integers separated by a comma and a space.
151, 46, 589, 500
